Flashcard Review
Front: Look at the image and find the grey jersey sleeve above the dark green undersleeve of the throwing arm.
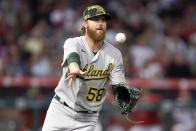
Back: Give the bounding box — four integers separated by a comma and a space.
61, 38, 79, 66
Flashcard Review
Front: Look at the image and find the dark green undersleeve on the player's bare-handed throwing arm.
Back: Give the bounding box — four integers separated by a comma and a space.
67, 52, 81, 66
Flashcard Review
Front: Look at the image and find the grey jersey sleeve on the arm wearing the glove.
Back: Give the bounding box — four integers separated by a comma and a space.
109, 53, 126, 85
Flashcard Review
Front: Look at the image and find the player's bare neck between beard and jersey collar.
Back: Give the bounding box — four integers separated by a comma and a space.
85, 34, 103, 52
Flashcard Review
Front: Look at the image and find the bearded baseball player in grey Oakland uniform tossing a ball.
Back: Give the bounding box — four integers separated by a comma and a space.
42, 5, 140, 131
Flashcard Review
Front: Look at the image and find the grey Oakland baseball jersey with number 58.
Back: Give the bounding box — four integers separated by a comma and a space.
55, 36, 125, 111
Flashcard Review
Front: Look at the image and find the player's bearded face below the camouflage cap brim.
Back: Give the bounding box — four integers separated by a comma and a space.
83, 16, 106, 41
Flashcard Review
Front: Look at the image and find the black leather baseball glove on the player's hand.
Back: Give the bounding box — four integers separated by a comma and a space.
112, 84, 142, 115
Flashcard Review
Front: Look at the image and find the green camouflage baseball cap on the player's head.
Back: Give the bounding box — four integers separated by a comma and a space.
82, 5, 111, 21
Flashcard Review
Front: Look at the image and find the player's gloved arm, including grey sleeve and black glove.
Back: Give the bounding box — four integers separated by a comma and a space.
110, 53, 142, 114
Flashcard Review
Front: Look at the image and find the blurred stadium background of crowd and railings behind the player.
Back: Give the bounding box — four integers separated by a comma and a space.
0, 0, 196, 131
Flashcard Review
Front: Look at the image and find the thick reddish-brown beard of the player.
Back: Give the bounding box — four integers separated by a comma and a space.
86, 26, 106, 41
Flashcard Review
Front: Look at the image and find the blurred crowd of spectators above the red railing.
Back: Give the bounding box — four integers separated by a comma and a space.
0, 0, 196, 79
